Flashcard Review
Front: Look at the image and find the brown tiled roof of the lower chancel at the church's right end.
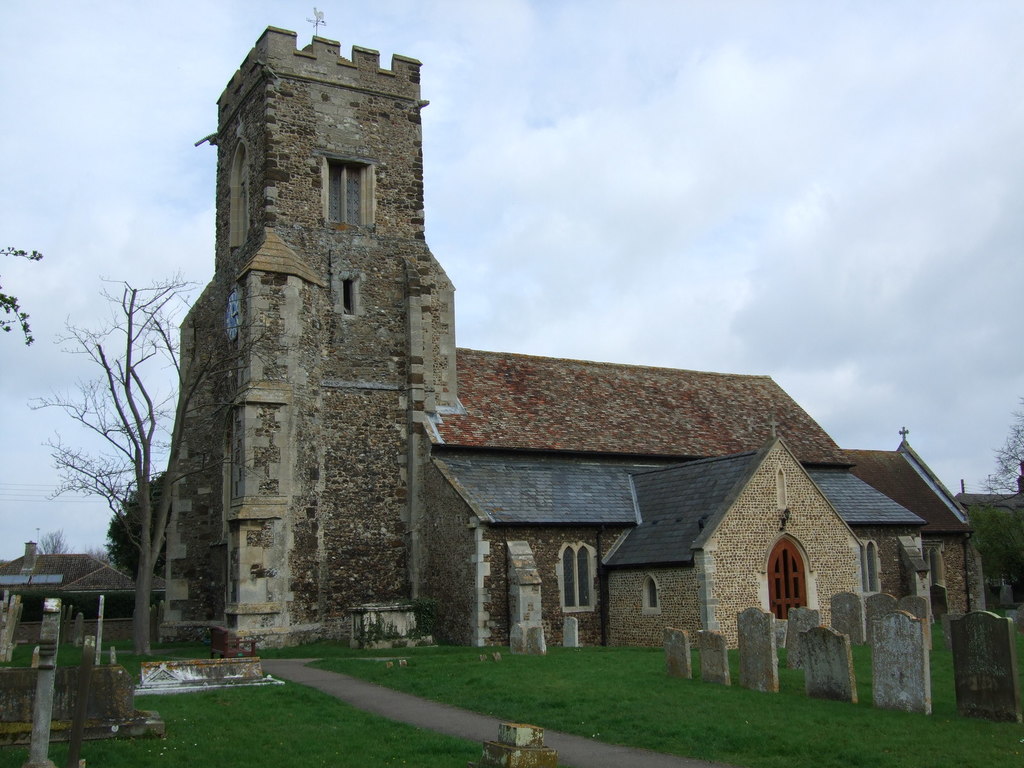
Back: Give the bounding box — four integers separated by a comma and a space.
846, 450, 970, 534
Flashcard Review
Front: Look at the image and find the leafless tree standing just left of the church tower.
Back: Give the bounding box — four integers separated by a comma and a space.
36, 276, 222, 653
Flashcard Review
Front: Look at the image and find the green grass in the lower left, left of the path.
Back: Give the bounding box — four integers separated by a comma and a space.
0, 645, 480, 768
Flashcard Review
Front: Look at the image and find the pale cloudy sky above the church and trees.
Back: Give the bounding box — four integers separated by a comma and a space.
0, 0, 1024, 559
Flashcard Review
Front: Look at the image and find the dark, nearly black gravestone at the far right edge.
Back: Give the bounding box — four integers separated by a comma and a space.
949, 610, 1021, 723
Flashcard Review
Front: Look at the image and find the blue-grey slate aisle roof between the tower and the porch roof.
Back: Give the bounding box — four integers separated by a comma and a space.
434, 454, 650, 525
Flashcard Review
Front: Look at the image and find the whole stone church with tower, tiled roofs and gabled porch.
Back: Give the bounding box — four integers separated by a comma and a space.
165, 28, 980, 645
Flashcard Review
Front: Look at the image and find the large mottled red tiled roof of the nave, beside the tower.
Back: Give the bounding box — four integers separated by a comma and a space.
438, 349, 849, 464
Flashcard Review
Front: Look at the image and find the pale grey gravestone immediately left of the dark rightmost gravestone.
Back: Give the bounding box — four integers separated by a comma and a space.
871, 610, 932, 715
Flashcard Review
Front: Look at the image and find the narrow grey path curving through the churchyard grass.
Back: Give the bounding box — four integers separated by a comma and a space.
262, 658, 728, 768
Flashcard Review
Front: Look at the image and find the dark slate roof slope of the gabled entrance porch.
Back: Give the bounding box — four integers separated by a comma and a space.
607, 452, 759, 567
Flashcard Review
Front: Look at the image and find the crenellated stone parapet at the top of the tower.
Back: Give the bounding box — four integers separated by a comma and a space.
218, 27, 422, 116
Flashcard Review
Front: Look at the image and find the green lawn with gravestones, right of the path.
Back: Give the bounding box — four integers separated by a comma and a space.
319, 626, 1024, 768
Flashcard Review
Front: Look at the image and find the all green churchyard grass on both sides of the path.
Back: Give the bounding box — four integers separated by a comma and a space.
0, 626, 1024, 768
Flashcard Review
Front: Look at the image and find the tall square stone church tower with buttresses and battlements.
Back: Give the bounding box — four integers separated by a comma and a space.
167, 28, 458, 645
